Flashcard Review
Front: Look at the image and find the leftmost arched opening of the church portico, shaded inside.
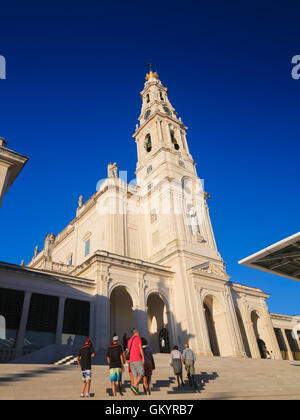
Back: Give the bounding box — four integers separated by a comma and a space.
110, 286, 136, 344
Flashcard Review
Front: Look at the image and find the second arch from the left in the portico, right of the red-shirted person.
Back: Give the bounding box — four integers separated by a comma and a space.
147, 293, 170, 353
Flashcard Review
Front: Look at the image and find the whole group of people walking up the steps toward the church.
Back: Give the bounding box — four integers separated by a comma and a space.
77, 329, 196, 397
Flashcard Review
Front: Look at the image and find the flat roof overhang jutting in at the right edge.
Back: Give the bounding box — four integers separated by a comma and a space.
239, 232, 300, 281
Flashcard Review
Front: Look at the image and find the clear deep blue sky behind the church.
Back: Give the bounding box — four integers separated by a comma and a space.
0, 0, 300, 315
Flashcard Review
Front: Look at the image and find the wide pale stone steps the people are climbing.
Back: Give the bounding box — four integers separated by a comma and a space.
0, 354, 300, 401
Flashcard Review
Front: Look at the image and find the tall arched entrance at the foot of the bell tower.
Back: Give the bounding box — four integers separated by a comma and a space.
203, 295, 232, 356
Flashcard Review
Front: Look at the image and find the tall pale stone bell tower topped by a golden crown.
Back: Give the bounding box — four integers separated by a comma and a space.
133, 65, 221, 266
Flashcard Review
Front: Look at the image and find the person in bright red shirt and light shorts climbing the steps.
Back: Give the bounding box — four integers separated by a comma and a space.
128, 330, 145, 395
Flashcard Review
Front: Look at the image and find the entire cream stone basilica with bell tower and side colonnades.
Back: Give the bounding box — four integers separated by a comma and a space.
0, 68, 296, 362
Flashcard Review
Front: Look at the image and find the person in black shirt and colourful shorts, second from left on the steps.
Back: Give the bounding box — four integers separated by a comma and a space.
106, 336, 124, 396
